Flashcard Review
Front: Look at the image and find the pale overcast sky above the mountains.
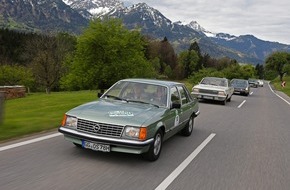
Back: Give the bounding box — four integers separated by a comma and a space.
121, 0, 290, 45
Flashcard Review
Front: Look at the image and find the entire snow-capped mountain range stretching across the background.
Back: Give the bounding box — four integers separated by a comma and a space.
0, 0, 290, 65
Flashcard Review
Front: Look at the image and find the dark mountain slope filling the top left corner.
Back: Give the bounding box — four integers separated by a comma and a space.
0, 0, 88, 33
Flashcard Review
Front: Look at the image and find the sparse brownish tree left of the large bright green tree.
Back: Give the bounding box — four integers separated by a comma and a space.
26, 34, 74, 94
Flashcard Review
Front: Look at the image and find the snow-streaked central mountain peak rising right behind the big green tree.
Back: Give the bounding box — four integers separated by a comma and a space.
98, 3, 201, 42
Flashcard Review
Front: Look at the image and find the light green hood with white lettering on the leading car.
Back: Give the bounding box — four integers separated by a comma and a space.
66, 99, 166, 126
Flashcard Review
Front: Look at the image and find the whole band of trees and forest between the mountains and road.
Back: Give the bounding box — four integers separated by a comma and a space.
0, 19, 280, 93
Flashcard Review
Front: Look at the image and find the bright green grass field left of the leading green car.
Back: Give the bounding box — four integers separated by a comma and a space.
0, 91, 97, 141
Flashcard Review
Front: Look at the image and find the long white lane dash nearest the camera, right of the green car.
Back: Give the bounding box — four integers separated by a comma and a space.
155, 133, 216, 190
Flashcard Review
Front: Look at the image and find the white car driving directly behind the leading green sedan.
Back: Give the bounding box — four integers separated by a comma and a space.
191, 77, 234, 105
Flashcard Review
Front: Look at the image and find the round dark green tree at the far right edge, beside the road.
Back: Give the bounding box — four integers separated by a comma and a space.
265, 52, 290, 81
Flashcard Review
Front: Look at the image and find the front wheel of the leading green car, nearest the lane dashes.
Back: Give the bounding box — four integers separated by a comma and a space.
142, 129, 163, 161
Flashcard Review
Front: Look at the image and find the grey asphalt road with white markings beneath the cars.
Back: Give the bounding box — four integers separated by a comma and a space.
0, 84, 290, 190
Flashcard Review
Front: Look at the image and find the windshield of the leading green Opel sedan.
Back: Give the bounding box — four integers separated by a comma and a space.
102, 81, 168, 106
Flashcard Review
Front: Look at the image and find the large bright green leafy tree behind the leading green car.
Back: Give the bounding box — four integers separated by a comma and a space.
61, 19, 155, 90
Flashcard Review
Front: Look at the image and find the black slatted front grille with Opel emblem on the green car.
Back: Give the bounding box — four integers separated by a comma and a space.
77, 119, 124, 137
